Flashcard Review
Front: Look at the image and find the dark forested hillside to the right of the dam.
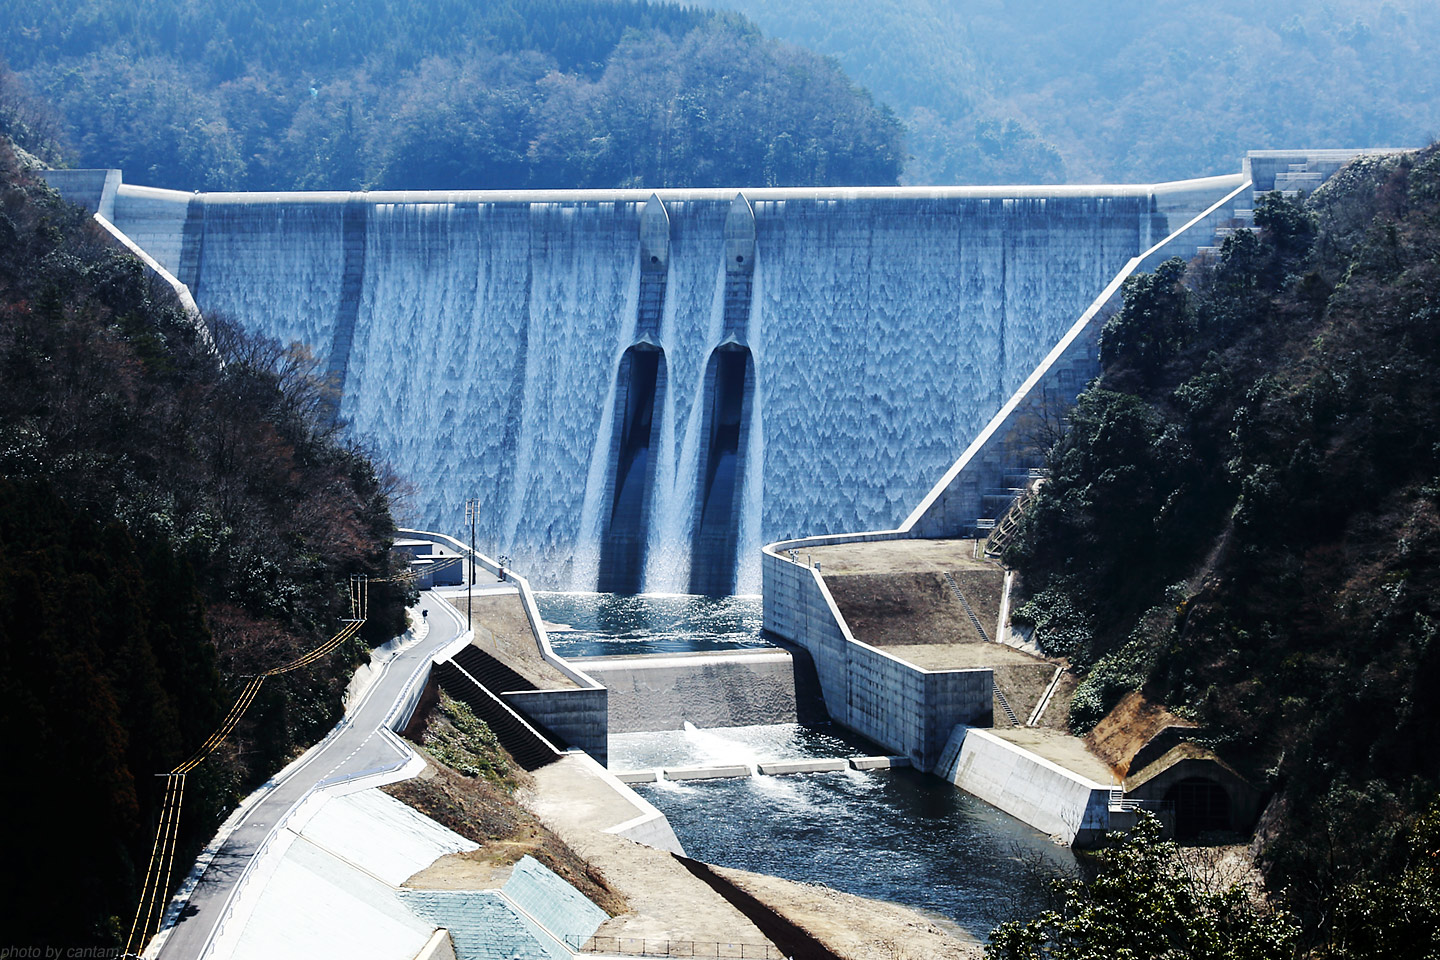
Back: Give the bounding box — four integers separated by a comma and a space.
1007, 147, 1440, 957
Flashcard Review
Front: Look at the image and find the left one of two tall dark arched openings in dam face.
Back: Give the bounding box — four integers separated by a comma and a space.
596, 344, 665, 593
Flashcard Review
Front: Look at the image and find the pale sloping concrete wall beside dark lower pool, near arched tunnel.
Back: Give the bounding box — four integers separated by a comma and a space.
935, 727, 1110, 845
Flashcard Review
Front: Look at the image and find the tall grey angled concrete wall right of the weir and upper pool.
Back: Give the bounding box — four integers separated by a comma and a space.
762, 552, 994, 770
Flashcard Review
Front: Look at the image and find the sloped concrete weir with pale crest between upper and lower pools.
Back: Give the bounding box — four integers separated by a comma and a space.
576, 651, 798, 733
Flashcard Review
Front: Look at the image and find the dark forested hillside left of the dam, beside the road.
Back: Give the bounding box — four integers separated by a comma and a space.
0, 140, 409, 948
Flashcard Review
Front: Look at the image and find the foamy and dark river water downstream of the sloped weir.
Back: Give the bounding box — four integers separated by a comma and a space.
611, 724, 1074, 937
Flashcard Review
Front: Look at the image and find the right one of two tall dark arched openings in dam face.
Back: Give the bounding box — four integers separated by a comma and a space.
690, 344, 755, 596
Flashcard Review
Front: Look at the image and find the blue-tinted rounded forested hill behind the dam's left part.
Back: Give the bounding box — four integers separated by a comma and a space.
0, 0, 904, 190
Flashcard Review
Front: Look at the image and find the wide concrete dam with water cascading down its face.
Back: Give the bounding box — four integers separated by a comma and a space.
58, 171, 1240, 594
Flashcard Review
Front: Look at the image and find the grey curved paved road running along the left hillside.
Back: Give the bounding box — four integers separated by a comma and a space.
160, 592, 464, 960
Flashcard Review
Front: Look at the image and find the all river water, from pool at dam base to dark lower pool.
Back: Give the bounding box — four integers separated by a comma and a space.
537, 593, 1074, 938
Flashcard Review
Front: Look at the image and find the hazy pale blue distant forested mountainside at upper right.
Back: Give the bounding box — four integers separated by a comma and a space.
706, 0, 1440, 183
